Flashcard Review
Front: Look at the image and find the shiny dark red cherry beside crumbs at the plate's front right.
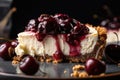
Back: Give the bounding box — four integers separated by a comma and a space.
85, 58, 106, 75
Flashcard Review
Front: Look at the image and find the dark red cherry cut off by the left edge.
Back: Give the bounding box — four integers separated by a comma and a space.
0, 42, 14, 60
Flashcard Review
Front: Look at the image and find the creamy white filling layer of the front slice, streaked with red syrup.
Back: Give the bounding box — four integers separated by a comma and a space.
15, 26, 98, 56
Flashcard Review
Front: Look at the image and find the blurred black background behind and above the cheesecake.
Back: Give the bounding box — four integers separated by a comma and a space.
0, 0, 120, 39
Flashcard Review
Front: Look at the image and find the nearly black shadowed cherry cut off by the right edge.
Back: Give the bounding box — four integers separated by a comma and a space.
105, 44, 120, 63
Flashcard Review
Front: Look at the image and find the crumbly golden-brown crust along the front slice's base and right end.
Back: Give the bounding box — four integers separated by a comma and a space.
13, 24, 107, 63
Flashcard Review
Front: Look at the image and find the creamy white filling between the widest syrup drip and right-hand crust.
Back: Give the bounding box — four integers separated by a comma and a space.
80, 27, 98, 55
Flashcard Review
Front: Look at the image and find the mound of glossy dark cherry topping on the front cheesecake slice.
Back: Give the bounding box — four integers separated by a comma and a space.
26, 14, 88, 35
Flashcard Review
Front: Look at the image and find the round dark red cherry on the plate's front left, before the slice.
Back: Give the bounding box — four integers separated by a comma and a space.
19, 56, 39, 75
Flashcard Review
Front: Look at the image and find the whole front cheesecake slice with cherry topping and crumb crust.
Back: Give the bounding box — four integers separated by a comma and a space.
15, 14, 107, 62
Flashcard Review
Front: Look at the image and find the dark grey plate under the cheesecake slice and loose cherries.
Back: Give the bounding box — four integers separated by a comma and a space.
0, 58, 120, 80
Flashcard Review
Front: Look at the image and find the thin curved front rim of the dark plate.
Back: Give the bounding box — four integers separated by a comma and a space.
0, 69, 120, 79
